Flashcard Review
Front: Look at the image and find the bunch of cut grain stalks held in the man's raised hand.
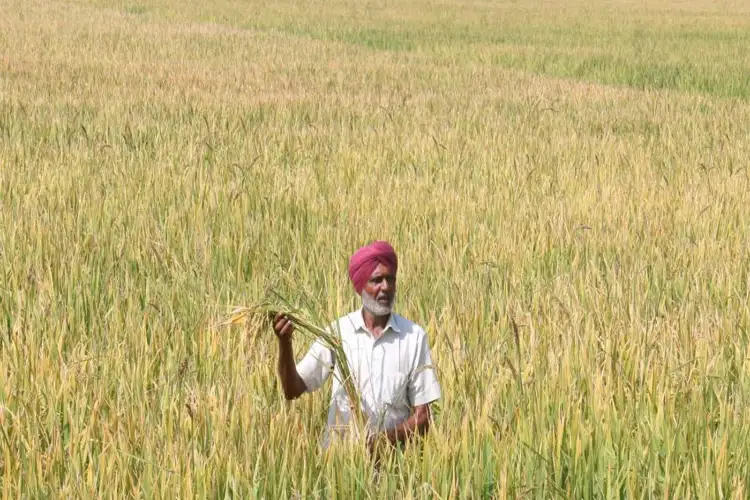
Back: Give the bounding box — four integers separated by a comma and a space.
223, 297, 365, 439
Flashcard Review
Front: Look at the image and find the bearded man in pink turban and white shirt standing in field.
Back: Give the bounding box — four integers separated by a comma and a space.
273, 241, 440, 447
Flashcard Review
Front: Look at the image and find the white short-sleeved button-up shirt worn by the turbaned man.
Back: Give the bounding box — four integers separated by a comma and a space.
297, 309, 440, 447
